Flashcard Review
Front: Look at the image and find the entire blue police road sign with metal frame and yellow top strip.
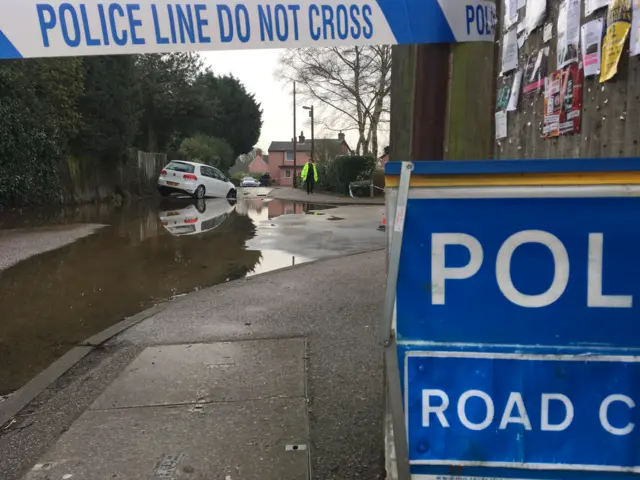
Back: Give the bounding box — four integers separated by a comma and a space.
383, 159, 640, 480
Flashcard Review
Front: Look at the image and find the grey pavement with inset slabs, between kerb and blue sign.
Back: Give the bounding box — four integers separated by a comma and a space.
0, 250, 385, 480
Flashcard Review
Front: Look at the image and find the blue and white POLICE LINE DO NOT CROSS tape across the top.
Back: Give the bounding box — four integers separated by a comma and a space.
0, 0, 496, 59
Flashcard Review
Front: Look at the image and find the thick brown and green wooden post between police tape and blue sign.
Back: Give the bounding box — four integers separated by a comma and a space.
389, 42, 496, 161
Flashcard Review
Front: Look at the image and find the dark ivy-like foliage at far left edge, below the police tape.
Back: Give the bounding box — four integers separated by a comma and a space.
0, 59, 83, 206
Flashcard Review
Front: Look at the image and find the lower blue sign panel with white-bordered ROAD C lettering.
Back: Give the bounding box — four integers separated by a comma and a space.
406, 352, 640, 472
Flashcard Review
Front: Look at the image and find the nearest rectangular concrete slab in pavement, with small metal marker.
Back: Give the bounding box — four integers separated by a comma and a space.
23, 398, 309, 480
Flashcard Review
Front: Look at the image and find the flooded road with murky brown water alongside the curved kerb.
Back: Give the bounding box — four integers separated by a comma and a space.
0, 198, 385, 395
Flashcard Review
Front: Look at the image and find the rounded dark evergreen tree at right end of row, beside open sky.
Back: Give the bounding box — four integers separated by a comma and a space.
196, 70, 262, 158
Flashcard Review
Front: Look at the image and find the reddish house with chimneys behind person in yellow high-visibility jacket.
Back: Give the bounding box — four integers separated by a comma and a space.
268, 132, 351, 186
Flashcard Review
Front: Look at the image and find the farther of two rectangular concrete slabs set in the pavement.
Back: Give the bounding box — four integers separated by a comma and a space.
91, 338, 305, 409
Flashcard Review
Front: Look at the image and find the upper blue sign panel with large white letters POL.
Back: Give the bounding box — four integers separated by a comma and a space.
397, 195, 640, 347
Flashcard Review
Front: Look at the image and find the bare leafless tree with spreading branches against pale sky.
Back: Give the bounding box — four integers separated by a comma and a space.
277, 45, 391, 155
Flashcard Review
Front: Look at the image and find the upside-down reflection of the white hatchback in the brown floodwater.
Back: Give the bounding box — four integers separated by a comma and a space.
158, 198, 236, 236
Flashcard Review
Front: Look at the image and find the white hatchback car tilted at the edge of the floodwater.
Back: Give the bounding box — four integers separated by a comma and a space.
158, 160, 236, 198
